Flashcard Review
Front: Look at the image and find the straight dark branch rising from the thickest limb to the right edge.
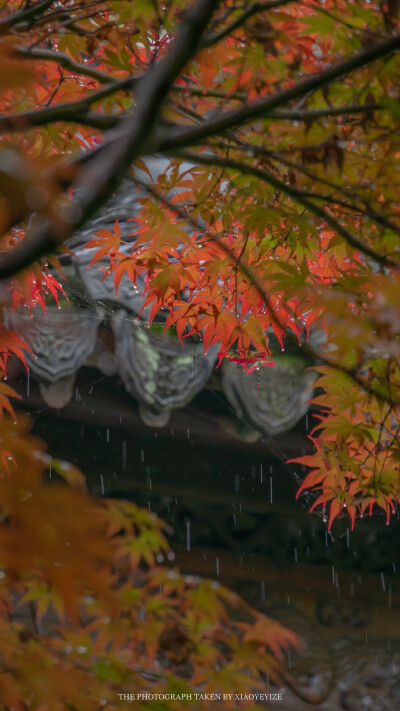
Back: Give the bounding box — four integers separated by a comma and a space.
159, 35, 400, 150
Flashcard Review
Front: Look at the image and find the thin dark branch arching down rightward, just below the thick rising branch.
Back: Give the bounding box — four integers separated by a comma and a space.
178, 151, 400, 270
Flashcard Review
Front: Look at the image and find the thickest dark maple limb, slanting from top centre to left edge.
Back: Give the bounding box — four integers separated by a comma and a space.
0, 0, 218, 278
